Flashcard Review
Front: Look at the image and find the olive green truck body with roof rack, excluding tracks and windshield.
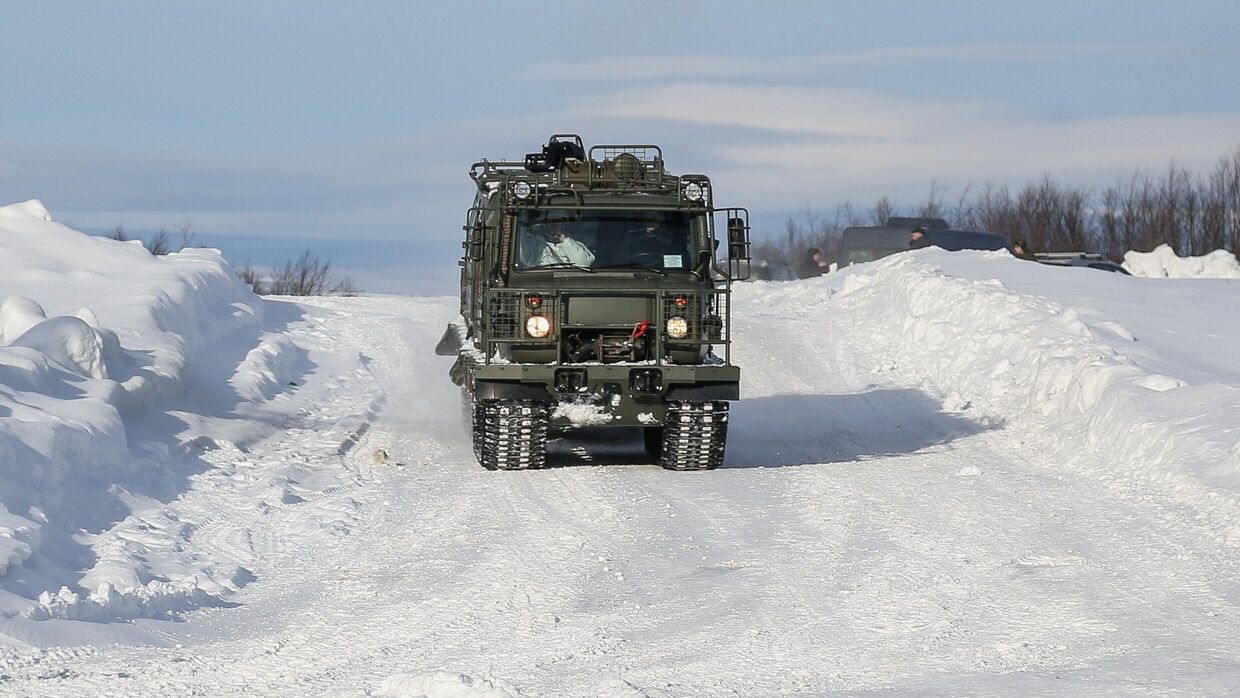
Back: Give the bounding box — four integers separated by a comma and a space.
446, 135, 749, 426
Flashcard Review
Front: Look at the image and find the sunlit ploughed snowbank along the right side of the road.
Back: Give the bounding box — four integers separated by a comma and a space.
738, 249, 1240, 535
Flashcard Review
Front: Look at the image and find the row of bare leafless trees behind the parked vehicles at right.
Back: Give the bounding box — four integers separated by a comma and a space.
755, 148, 1240, 263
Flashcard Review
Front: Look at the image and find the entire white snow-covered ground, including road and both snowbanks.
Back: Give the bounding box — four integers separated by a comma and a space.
0, 203, 1240, 698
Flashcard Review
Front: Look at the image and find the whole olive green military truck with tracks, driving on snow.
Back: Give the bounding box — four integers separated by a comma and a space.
436, 134, 749, 470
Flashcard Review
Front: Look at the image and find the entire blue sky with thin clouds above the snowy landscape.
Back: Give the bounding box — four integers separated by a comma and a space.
0, 0, 1240, 293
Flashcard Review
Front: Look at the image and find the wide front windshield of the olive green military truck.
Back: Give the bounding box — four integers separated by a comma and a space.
512, 208, 693, 272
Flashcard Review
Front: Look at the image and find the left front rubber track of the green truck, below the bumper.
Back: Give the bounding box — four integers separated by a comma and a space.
474, 400, 551, 470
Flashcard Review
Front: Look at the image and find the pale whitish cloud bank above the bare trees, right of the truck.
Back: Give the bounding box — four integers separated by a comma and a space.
567, 84, 1240, 207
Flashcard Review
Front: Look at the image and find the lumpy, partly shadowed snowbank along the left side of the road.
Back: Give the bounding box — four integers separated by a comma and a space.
0, 201, 286, 620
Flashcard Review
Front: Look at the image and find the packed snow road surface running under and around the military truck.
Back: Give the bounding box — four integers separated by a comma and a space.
0, 265, 1240, 698
